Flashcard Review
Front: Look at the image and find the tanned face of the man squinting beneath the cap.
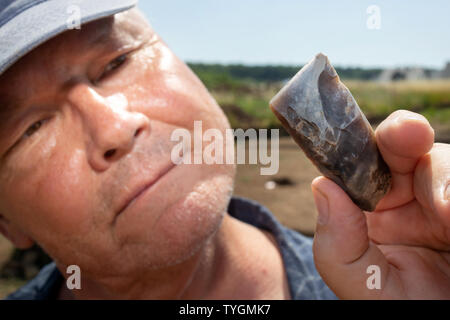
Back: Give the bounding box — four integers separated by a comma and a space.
0, 10, 235, 276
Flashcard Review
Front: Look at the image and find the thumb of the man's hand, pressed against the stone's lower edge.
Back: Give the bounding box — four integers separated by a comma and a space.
311, 177, 398, 299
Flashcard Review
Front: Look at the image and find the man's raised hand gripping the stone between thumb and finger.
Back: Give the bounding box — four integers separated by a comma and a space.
312, 111, 450, 299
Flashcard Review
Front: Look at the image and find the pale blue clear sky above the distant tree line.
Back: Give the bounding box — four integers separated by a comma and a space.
138, 0, 450, 69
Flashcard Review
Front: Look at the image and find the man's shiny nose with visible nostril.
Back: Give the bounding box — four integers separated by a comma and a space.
68, 83, 150, 171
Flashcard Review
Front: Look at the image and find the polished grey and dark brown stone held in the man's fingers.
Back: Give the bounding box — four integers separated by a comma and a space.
270, 53, 391, 211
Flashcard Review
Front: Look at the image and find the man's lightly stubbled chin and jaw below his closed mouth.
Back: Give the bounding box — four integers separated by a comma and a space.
111, 165, 234, 269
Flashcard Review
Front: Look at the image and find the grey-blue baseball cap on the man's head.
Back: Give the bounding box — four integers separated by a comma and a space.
0, 0, 138, 74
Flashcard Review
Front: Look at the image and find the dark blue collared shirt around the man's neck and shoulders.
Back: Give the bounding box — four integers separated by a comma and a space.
6, 197, 336, 300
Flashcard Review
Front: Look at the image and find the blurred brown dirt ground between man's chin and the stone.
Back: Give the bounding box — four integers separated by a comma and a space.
235, 137, 320, 235
